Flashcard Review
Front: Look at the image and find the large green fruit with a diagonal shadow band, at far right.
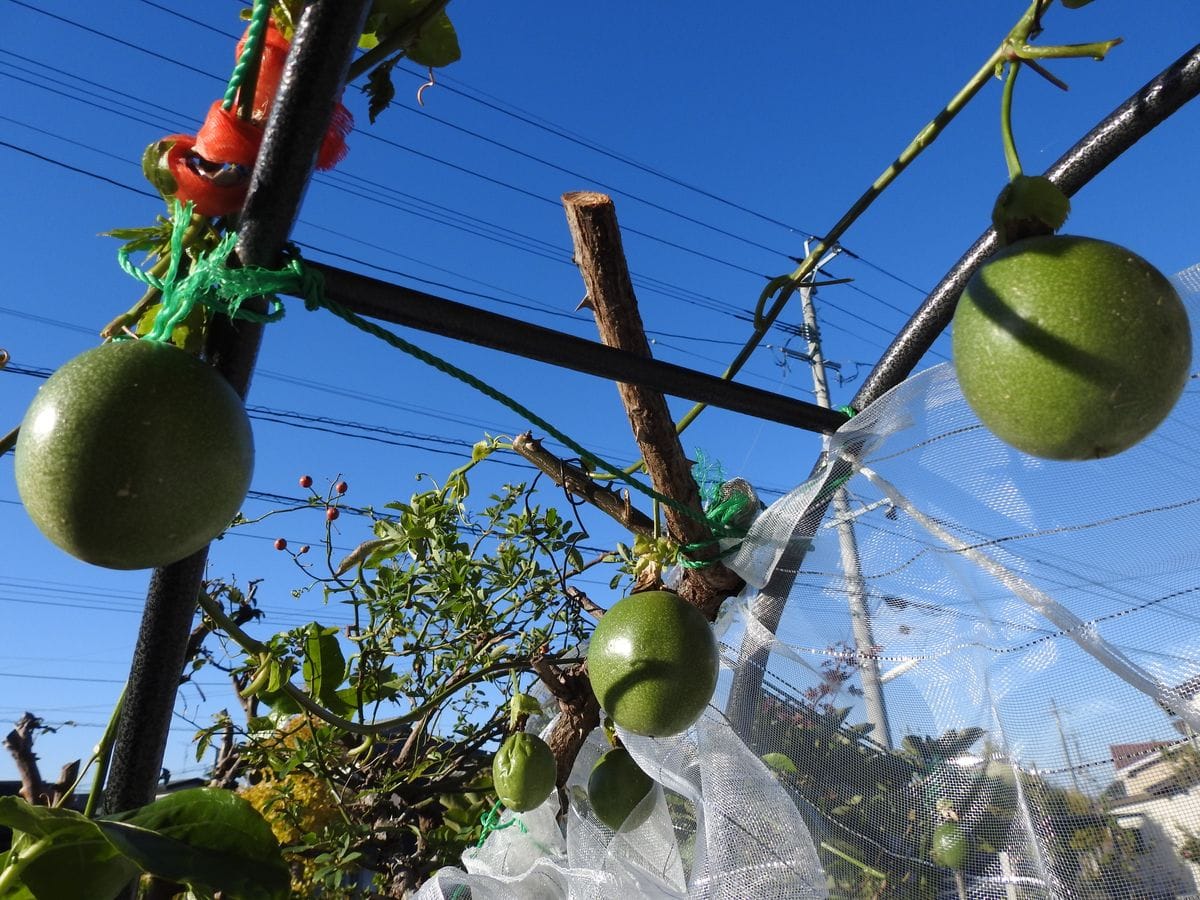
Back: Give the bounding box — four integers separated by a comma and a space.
953, 235, 1192, 460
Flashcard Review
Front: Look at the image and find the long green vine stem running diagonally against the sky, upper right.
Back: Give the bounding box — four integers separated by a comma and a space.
676, 0, 1070, 432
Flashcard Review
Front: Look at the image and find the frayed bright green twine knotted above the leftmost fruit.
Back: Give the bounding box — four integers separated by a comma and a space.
116, 200, 295, 342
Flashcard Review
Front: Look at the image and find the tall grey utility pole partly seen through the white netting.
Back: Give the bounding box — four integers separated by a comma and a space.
799, 242, 892, 749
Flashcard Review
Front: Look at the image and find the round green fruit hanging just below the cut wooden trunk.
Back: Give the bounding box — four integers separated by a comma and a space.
588, 590, 720, 737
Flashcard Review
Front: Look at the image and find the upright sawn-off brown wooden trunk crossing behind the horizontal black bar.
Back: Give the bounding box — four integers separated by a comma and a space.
563, 191, 743, 618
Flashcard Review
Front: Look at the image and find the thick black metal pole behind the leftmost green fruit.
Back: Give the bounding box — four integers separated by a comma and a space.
104, 0, 370, 812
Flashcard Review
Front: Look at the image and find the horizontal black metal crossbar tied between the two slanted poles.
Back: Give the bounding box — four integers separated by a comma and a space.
308, 263, 846, 432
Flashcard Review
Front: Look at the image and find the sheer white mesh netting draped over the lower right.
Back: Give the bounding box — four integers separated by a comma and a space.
419, 268, 1200, 900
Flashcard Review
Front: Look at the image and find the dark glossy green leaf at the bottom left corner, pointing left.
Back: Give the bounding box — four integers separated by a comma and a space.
103, 787, 290, 900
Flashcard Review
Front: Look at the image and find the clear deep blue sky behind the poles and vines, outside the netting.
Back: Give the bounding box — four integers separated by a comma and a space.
0, 0, 1200, 778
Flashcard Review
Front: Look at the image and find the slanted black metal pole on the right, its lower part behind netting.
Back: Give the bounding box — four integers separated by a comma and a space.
727, 38, 1200, 736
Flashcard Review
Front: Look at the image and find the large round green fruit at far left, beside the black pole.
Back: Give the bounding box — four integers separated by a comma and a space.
14, 341, 254, 569
